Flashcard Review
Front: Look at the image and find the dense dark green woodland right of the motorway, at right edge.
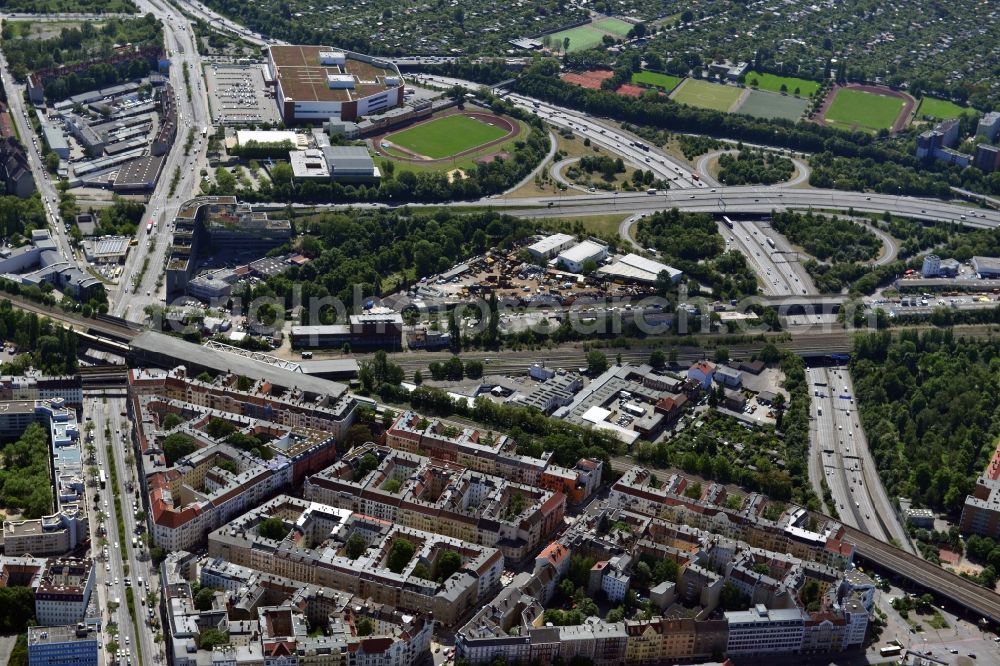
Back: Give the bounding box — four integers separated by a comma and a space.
851, 329, 1000, 517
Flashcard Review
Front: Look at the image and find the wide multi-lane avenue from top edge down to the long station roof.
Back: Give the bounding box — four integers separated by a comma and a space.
110, 0, 213, 322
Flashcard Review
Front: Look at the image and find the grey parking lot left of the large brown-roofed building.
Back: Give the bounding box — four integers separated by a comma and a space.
205, 63, 281, 125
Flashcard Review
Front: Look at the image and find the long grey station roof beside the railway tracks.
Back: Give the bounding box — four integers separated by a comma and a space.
131, 331, 347, 397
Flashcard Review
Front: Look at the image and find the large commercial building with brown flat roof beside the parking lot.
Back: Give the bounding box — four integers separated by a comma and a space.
267, 45, 403, 123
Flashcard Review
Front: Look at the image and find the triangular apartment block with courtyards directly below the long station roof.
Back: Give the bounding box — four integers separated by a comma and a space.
129, 367, 355, 550
